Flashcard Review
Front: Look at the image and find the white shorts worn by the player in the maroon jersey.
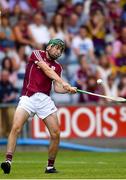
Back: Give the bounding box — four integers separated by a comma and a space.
18, 93, 57, 119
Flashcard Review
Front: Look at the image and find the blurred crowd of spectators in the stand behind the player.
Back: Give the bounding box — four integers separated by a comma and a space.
0, 0, 126, 103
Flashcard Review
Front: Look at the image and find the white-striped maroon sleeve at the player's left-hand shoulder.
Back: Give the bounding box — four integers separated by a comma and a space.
29, 50, 42, 62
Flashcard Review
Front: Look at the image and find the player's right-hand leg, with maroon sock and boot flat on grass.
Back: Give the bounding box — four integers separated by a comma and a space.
44, 112, 60, 173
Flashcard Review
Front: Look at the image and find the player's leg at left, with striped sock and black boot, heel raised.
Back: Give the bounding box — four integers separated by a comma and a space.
1, 107, 29, 174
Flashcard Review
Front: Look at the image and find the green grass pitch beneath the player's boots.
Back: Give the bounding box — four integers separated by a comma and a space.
0, 150, 126, 179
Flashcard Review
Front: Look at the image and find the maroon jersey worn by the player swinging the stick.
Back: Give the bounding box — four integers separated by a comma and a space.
22, 50, 62, 96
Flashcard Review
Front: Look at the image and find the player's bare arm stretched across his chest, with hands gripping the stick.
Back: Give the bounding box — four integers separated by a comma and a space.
35, 60, 76, 93
